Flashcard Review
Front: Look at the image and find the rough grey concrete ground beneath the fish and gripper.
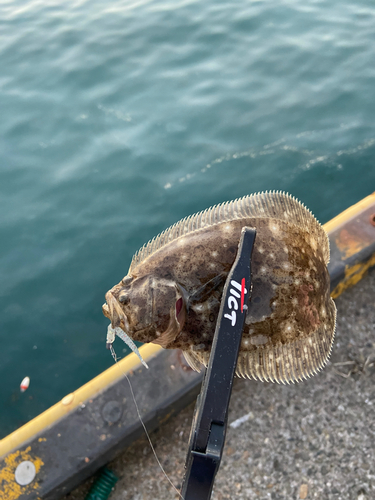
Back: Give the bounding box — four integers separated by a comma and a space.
64, 270, 375, 500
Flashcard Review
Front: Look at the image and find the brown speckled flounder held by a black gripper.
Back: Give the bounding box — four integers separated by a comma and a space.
103, 192, 336, 383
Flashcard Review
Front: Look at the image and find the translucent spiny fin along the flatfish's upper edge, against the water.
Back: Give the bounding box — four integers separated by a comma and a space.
128, 191, 329, 274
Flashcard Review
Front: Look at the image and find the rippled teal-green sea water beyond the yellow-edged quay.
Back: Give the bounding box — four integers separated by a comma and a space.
0, 0, 375, 437
